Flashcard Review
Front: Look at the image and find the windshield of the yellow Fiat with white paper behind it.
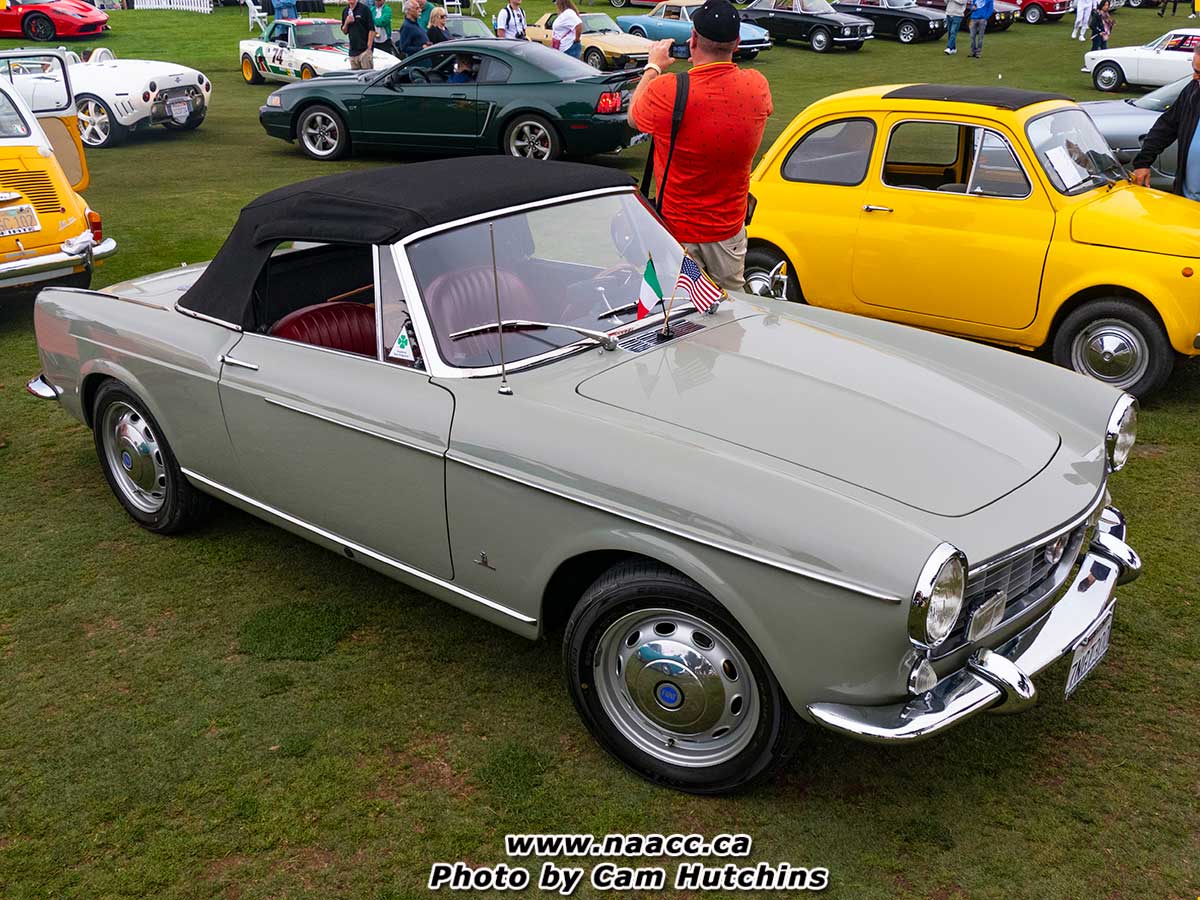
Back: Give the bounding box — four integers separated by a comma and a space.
1026, 108, 1127, 194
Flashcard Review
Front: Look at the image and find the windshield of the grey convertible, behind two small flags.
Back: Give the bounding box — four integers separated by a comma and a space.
408, 191, 692, 368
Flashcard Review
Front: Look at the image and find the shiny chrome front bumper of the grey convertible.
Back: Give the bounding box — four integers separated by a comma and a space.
809, 506, 1141, 744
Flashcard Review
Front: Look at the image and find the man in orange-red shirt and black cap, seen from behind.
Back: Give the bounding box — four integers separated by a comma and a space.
629, 0, 774, 290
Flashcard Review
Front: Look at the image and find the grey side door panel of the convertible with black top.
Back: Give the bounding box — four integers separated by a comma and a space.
221, 334, 454, 578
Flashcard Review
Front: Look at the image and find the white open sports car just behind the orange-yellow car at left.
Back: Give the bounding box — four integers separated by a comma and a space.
10, 47, 212, 148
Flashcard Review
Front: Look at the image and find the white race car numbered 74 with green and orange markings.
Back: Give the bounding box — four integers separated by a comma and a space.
239, 19, 400, 84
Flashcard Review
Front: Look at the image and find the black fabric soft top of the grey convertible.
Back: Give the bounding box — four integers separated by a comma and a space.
179, 156, 634, 325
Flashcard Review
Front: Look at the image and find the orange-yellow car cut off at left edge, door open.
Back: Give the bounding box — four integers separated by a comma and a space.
0, 50, 116, 299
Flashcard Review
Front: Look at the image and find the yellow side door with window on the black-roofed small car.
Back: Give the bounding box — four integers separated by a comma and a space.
851, 114, 1055, 337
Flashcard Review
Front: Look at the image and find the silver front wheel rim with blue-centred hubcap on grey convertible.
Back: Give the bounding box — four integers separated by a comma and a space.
592, 608, 761, 768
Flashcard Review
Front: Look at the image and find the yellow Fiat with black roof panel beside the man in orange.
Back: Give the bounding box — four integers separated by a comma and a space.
746, 84, 1200, 396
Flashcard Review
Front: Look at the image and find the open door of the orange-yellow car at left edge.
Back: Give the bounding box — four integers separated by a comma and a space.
0, 50, 89, 192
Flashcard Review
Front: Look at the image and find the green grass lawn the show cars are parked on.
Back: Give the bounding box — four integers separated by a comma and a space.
0, 0, 1200, 900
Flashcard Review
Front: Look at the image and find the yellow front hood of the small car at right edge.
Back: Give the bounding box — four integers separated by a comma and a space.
1070, 185, 1200, 258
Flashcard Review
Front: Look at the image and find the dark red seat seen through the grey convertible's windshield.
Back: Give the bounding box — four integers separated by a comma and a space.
425, 265, 539, 364
